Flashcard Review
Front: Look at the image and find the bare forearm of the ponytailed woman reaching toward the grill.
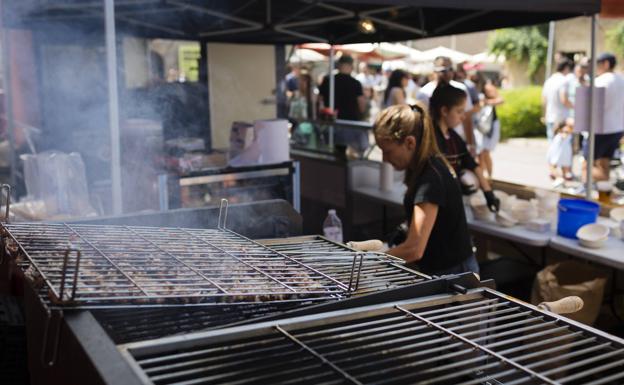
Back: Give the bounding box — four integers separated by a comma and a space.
386, 202, 438, 262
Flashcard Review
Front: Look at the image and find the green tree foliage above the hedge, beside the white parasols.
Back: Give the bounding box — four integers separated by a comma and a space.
488, 24, 548, 78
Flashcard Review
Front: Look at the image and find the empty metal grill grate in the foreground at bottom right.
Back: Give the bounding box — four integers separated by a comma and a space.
123, 289, 624, 385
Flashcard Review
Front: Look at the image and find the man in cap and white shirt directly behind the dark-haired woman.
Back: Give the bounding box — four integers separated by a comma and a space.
416, 56, 477, 156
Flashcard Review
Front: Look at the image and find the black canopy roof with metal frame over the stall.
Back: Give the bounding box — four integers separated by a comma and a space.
3, 0, 600, 44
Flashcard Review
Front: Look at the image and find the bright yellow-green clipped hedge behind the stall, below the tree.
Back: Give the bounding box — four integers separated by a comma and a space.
496, 86, 546, 138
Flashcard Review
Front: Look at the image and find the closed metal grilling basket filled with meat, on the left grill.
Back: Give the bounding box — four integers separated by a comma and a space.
2, 223, 357, 307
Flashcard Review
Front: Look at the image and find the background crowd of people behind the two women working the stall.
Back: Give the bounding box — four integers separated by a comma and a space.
285, 55, 503, 178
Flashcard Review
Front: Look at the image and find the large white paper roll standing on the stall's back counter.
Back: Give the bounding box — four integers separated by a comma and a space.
254, 119, 290, 164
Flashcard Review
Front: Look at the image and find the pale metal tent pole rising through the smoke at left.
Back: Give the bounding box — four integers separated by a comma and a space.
104, 0, 122, 215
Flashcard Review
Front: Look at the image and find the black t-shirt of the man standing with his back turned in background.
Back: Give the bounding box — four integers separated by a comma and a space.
319, 73, 363, 120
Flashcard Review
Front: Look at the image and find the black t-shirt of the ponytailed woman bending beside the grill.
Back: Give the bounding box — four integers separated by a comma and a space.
403, 158, 472, 274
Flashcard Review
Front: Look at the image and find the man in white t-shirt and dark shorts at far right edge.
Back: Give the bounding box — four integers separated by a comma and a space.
584, 52, 624, 181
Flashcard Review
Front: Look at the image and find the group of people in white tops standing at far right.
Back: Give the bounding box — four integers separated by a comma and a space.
542, 53, 624, 188
